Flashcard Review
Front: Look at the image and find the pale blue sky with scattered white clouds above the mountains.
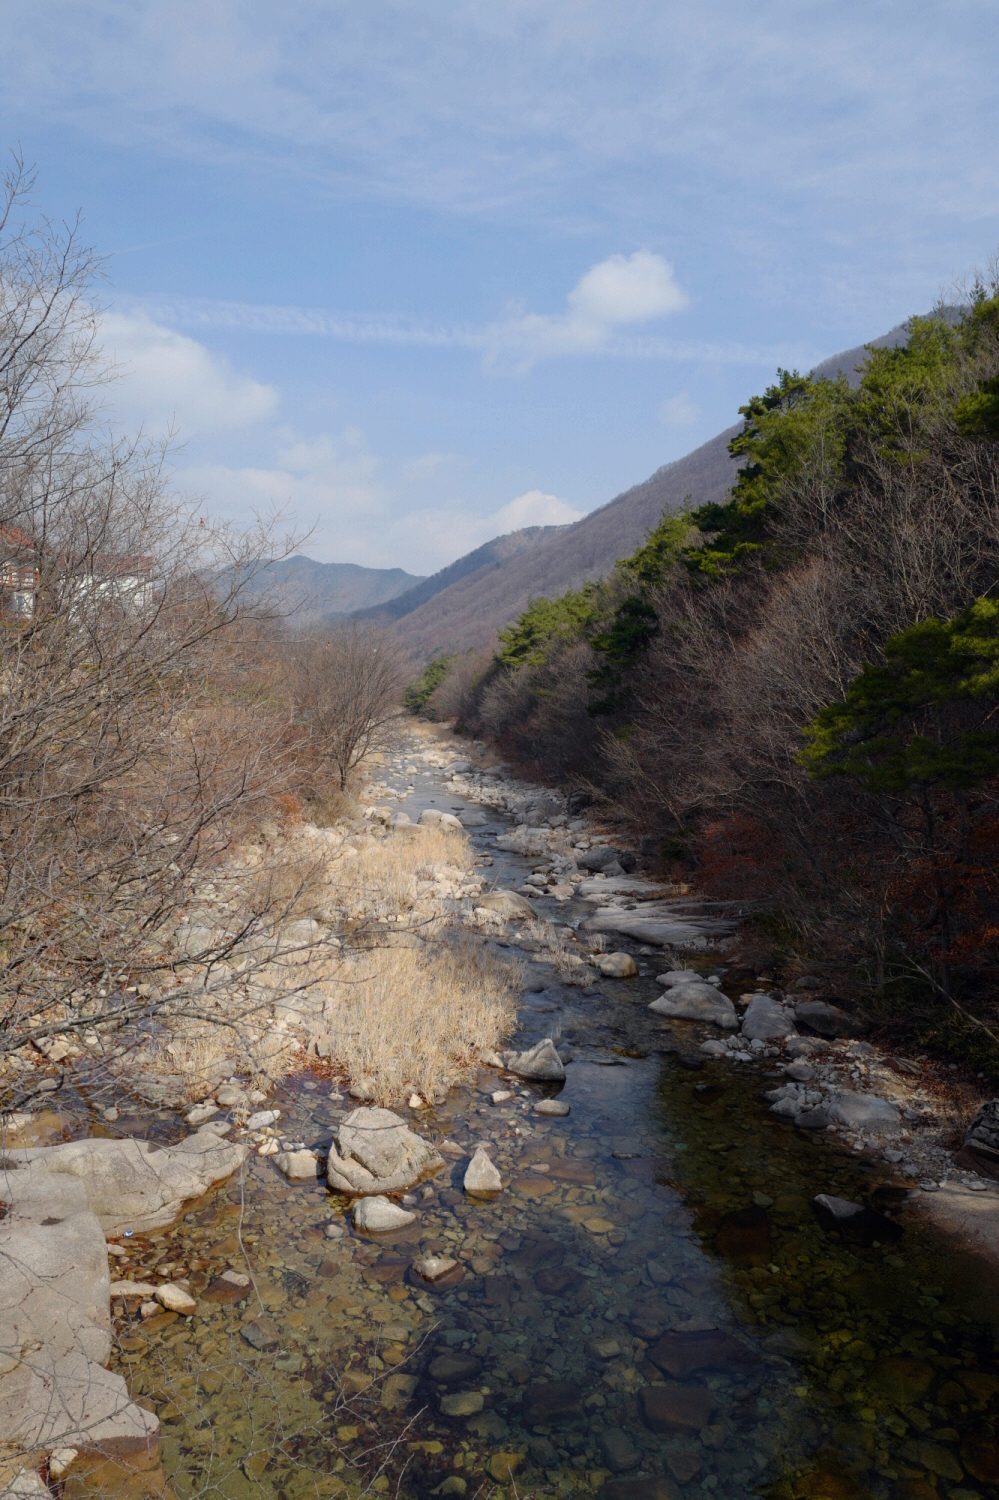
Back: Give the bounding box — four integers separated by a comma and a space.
0, 0, 999, 573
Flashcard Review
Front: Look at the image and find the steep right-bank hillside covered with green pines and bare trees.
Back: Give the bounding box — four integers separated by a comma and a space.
429, 292, 999, 1058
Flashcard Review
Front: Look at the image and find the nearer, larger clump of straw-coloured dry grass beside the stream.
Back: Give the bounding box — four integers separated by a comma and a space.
316, 939, 519, 1103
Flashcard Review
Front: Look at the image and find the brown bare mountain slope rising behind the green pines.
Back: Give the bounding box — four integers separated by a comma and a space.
381, 425, 741, 663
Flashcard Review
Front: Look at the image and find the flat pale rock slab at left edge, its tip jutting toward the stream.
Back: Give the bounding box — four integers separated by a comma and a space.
3, 1124, 249, 1236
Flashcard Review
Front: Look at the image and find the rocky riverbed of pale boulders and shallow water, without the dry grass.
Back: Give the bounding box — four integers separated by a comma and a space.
0, 729, 999, 1500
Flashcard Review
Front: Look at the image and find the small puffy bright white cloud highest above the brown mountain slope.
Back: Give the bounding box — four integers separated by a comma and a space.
486, 251, 687, 374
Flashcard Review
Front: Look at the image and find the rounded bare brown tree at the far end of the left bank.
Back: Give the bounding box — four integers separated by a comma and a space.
294, 623, 404, 791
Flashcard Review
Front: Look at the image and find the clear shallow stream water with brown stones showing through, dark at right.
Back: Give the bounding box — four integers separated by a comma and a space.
79, 750, 999, 1500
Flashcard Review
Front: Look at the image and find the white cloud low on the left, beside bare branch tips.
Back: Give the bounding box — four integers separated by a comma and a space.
101, 309, 279, 438
